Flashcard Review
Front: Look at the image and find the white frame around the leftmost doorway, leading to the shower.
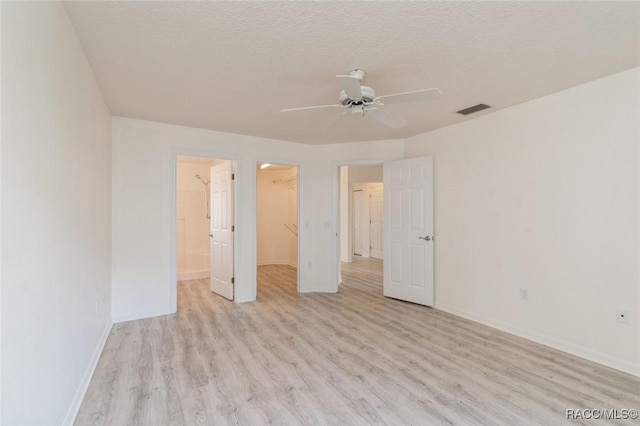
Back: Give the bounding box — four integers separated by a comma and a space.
169, 149, 240, 312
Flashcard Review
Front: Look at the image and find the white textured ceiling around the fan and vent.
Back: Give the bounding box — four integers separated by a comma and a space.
65, 1, 640, 144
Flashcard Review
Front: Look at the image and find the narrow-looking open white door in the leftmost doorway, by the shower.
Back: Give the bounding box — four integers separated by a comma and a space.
209, 161, 234, 300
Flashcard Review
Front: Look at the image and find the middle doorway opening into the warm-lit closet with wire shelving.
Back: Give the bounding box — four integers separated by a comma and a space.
256, 163, 299, 299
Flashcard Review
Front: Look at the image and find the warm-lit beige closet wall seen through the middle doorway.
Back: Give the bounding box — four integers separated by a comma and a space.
257, 167, 298, 266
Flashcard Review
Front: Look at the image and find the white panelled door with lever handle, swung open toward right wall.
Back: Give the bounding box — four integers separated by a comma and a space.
383, 157, 434, 306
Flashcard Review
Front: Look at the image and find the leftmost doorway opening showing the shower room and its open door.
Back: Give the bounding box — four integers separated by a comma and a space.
176, 156, 235, 300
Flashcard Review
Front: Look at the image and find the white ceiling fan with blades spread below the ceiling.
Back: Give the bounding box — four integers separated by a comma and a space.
280, 69, 442, 129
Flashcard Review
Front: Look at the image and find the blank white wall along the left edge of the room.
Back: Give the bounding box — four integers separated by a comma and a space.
1, 2, 111, 425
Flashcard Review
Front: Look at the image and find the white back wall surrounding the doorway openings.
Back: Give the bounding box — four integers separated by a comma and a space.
112, 117, 403, 321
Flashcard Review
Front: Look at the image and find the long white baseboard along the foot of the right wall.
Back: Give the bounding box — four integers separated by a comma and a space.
434, 304, 640, 377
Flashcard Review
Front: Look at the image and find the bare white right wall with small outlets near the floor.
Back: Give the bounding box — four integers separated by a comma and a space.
406, 68, 640, 374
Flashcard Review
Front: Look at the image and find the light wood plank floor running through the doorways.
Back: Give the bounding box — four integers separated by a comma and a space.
75, 258, 640, 426
